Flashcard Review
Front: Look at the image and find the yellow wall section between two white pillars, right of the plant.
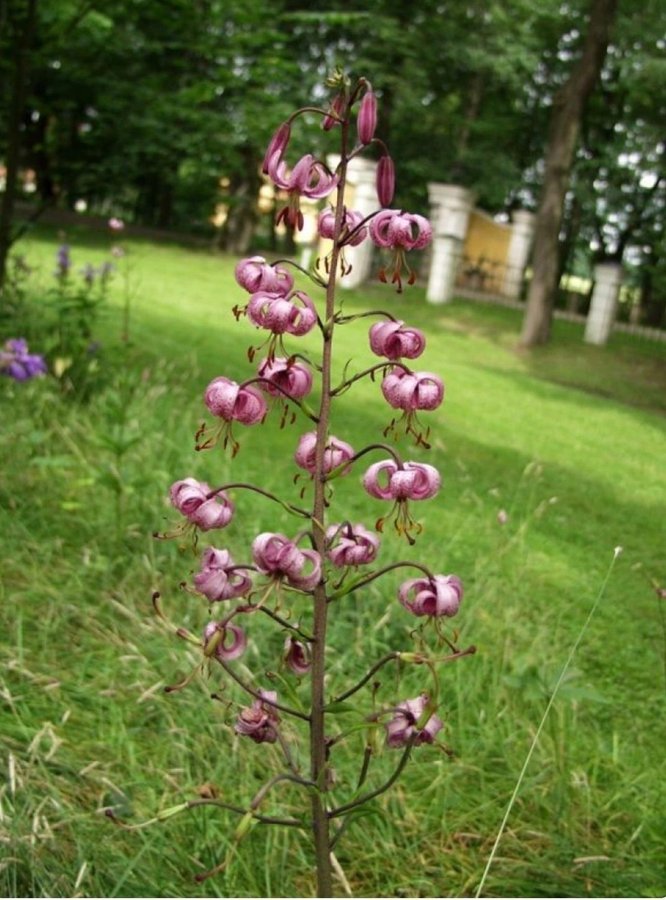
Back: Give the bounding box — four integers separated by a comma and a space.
457, 209, 511, 292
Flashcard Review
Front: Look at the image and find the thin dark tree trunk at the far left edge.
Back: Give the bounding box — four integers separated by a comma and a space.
0, 0, 37, 288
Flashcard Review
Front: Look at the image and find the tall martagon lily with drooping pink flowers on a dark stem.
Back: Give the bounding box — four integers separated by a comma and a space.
114, 72, 474, 897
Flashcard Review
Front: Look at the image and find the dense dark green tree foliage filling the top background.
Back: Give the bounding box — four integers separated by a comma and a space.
0, 0, 666, 322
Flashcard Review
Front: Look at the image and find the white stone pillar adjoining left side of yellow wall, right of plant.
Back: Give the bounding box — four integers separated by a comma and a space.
426, 182, 473, 303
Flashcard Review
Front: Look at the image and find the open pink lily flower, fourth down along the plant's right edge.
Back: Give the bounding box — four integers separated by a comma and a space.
363, 459, 441, 544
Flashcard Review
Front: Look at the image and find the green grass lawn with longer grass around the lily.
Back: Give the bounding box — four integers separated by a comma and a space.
0, 223, 666, 897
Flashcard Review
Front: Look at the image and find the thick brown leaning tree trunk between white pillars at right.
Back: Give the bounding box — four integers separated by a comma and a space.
521, 0, 617, 347
